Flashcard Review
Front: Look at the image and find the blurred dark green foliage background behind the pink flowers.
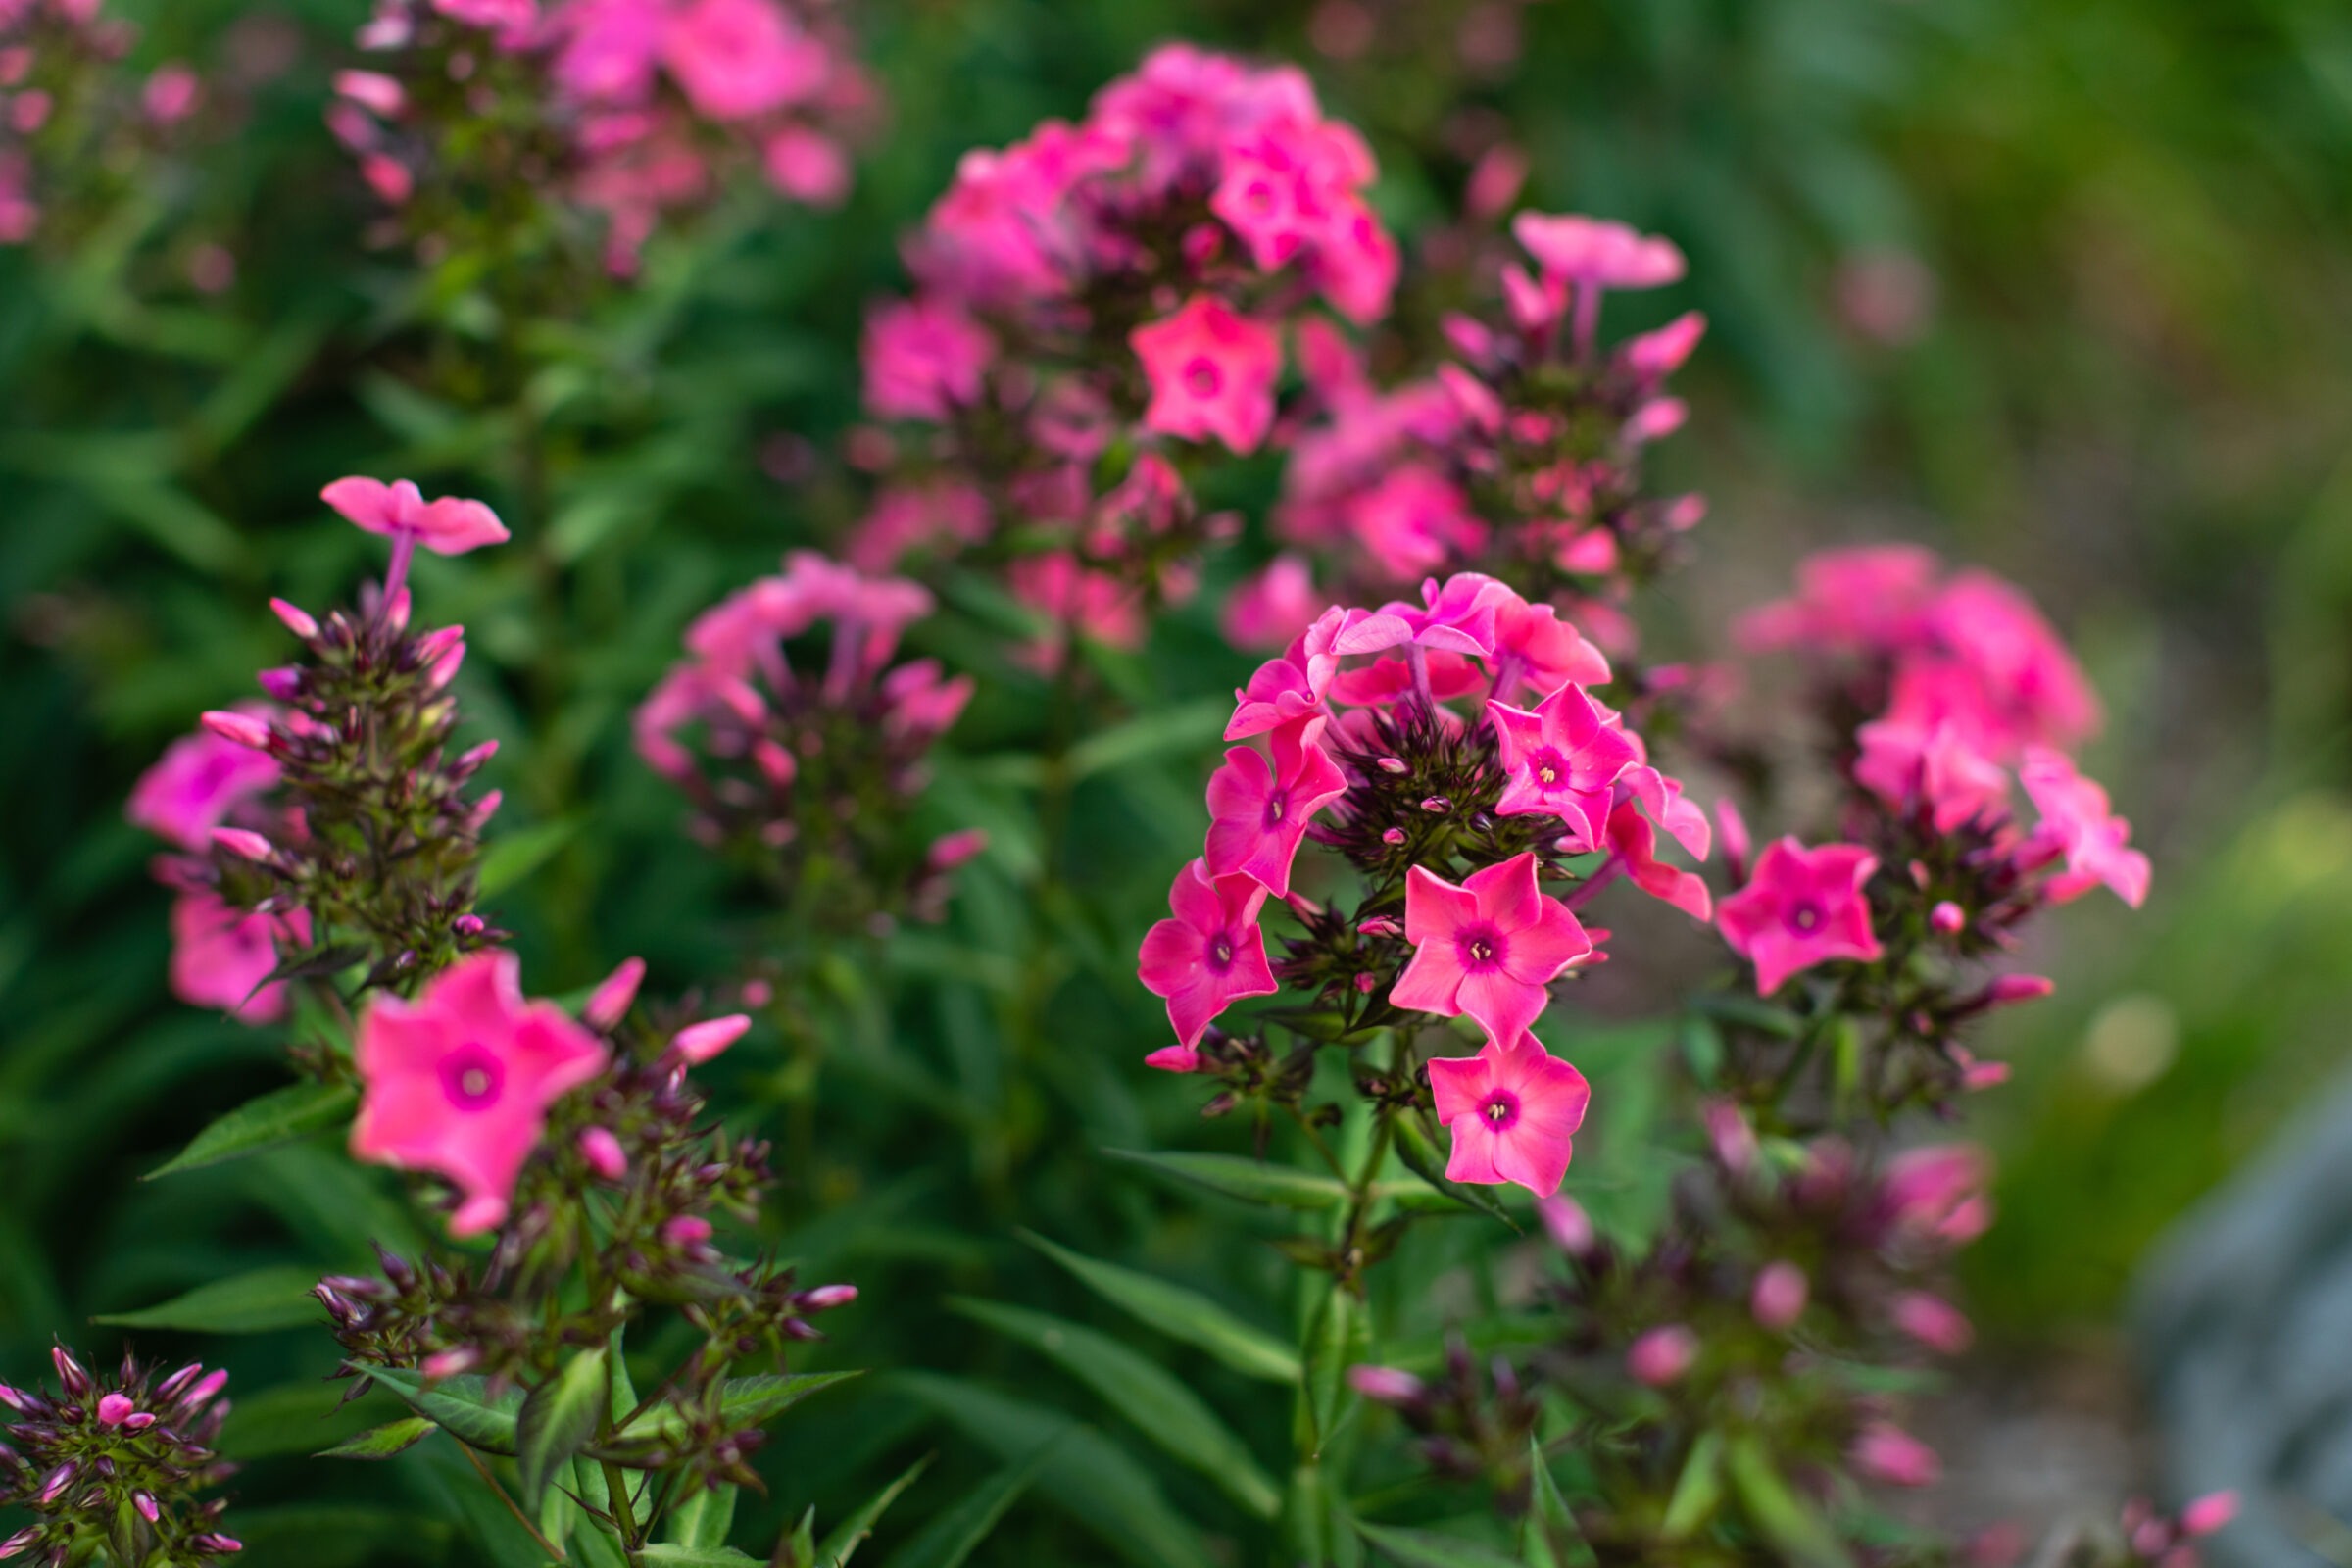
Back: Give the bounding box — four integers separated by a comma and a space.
0, 0, 2352, 1563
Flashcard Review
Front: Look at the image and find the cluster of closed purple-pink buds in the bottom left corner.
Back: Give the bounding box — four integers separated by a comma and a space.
0, 1345, 240, 1568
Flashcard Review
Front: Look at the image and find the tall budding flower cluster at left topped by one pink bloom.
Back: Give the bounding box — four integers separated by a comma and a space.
129, 479, 506, 1022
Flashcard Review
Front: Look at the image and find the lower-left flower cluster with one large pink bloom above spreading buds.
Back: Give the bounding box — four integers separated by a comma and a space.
318, 953, 857, 1528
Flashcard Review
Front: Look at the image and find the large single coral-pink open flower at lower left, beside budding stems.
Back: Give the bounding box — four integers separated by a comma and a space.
351, 953, 610, 1237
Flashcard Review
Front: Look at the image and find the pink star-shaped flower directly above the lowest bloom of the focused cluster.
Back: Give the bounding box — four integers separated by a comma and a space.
1388, 851, 1592, 1044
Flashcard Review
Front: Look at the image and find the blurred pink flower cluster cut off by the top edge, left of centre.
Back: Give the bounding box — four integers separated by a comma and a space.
329, 0, 872, 275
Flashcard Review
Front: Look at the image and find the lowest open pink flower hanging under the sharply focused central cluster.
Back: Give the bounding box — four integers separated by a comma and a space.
1430, 1034, 1592, 1199
